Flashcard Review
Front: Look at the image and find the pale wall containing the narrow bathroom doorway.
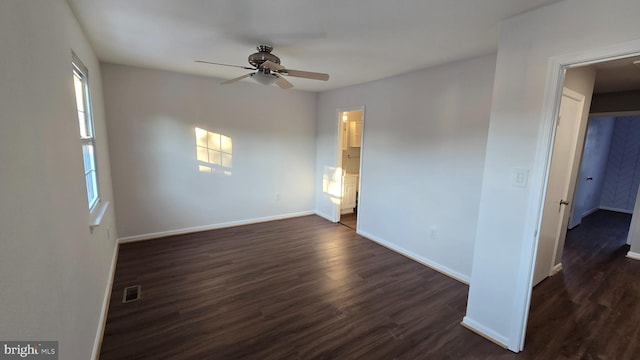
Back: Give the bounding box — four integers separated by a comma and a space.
316, 55, 495, 281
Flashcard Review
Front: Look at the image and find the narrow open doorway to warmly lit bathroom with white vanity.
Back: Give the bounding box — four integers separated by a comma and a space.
337, 108, 364, 231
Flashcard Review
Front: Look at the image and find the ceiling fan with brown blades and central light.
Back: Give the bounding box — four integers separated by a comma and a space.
196, 45, 329, 89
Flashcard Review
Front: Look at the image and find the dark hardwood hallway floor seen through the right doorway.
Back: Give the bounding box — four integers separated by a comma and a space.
522, 211, 640, 359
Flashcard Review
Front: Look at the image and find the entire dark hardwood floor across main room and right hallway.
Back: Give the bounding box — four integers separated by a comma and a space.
100, 211, 640, 360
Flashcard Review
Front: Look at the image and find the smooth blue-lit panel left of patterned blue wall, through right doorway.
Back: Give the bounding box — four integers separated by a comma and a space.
569, 117, 615, 228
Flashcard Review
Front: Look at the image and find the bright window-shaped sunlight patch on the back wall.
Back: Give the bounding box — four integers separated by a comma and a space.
195, 127, 233, 176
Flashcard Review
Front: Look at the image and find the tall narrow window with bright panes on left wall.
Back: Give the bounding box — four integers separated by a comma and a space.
73, 54, 99, 210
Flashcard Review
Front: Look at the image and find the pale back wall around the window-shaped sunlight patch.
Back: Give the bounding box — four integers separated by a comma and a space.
102, 64, 317, 237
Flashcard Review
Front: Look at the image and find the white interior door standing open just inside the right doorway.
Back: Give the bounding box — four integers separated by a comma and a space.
533, 88, 584, 285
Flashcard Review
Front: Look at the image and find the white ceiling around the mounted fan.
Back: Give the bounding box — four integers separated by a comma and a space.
68, 0, 557, 91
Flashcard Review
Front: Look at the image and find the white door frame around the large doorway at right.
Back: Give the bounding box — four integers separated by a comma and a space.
509, 40, 640, 351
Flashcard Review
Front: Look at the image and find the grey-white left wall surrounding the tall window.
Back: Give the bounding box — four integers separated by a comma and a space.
0, 0, 115, 359
